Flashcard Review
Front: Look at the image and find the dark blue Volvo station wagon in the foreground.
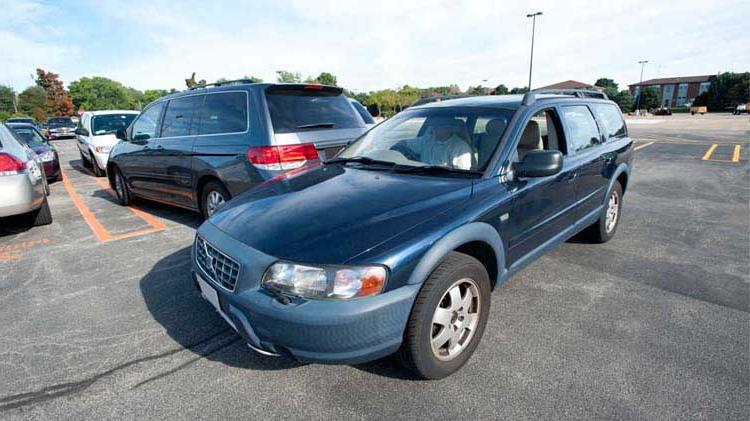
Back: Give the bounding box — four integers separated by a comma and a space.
193, 93, 633, 379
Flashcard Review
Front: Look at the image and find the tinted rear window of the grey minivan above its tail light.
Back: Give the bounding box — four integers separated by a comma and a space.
266, 88, 364, 134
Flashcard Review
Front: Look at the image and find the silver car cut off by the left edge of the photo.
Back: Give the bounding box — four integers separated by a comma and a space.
0, 124, 52, 225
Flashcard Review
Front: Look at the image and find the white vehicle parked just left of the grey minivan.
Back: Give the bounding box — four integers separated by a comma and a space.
76, 110, 140, 177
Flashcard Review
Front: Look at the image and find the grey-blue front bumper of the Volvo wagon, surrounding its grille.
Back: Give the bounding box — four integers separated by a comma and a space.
192, 223, 419, 364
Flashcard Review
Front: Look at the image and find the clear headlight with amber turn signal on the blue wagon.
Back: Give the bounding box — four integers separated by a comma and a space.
262, 262, 387, 299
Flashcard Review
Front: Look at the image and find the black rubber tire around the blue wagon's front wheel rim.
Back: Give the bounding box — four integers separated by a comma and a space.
398, 252, 491, 379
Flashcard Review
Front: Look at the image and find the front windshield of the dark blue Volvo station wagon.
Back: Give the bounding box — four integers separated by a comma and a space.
335, 107, 514, 172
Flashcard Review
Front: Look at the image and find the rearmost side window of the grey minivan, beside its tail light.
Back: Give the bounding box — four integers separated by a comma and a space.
193, 92, 247, 134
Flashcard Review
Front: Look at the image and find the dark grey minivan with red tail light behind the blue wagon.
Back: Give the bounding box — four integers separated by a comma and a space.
107, 82, 367, 217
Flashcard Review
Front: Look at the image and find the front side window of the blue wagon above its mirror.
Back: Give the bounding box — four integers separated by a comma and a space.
516, 108, 567, 161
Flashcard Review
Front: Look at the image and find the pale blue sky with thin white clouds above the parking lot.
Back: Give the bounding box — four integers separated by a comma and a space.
0, 0, 750, 92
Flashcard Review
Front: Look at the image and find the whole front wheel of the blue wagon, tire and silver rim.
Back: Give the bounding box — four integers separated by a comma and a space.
399, 252, 490, 379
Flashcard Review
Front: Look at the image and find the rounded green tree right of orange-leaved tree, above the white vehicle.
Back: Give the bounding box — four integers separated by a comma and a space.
70, 76, 134, 111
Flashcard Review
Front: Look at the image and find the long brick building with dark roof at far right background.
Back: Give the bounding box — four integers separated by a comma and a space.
628, 75, 716, 108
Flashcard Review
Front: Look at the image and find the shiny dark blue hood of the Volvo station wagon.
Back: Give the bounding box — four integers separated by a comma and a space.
208, 165, 472, 264
